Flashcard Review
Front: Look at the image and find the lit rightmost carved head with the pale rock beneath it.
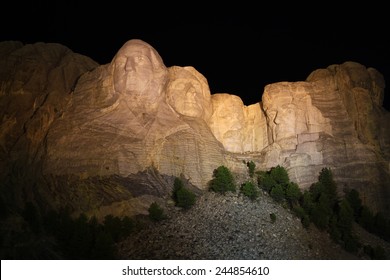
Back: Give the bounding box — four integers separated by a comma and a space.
260, 82, 333, 188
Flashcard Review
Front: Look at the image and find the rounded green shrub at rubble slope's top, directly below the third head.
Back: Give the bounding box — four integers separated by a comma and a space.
209, 165, 236, 194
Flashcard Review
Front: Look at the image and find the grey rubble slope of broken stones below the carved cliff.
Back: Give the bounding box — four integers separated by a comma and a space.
118, 192, 368, 260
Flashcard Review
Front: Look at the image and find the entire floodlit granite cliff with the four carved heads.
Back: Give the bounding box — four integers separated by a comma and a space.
0, 39, 390, 216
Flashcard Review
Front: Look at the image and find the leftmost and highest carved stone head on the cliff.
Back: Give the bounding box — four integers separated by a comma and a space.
111, 39, 168, 114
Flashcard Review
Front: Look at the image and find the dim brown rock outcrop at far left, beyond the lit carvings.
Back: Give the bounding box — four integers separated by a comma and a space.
0, 42, 98, 168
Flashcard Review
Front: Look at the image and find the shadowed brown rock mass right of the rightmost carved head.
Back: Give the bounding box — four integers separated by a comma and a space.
307, 62, 390, 211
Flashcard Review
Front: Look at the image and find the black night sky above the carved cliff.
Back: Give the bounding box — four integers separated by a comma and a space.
0, 0, 390, 110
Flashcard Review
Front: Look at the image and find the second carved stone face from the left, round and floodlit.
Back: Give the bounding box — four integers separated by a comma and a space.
167, 66, 211, 120
